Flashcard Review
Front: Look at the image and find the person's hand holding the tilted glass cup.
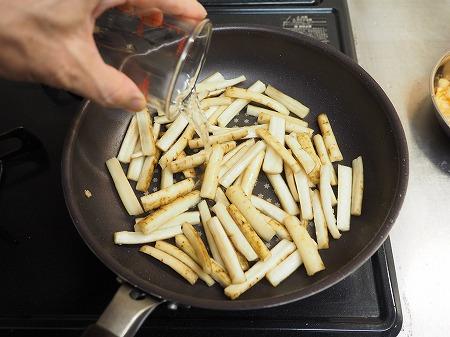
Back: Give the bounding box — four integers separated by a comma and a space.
0, 0, 206, 111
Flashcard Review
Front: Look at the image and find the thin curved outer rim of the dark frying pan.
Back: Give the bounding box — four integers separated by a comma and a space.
62, 24, 409, 310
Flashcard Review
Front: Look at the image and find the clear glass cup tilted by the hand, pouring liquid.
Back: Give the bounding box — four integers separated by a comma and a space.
94, 8, 212, 120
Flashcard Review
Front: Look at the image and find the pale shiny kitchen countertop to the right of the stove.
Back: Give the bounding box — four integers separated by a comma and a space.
348, 0, 450, 337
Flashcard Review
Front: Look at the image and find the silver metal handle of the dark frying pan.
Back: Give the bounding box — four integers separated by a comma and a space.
82, 283, 164, 337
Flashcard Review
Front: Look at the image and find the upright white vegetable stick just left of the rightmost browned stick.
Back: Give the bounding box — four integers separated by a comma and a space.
337, 165, 352, 231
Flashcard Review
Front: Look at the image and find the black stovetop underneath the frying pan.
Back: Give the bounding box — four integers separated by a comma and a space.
0, 0, 402, 336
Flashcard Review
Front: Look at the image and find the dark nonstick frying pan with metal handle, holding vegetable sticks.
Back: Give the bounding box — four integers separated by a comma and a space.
62, 25, 408, 336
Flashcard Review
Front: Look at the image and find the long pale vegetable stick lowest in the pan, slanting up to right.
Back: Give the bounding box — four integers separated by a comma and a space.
224, 240, 295, 300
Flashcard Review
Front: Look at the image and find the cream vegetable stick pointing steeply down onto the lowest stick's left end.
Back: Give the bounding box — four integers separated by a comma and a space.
208, 217, 245, 283
